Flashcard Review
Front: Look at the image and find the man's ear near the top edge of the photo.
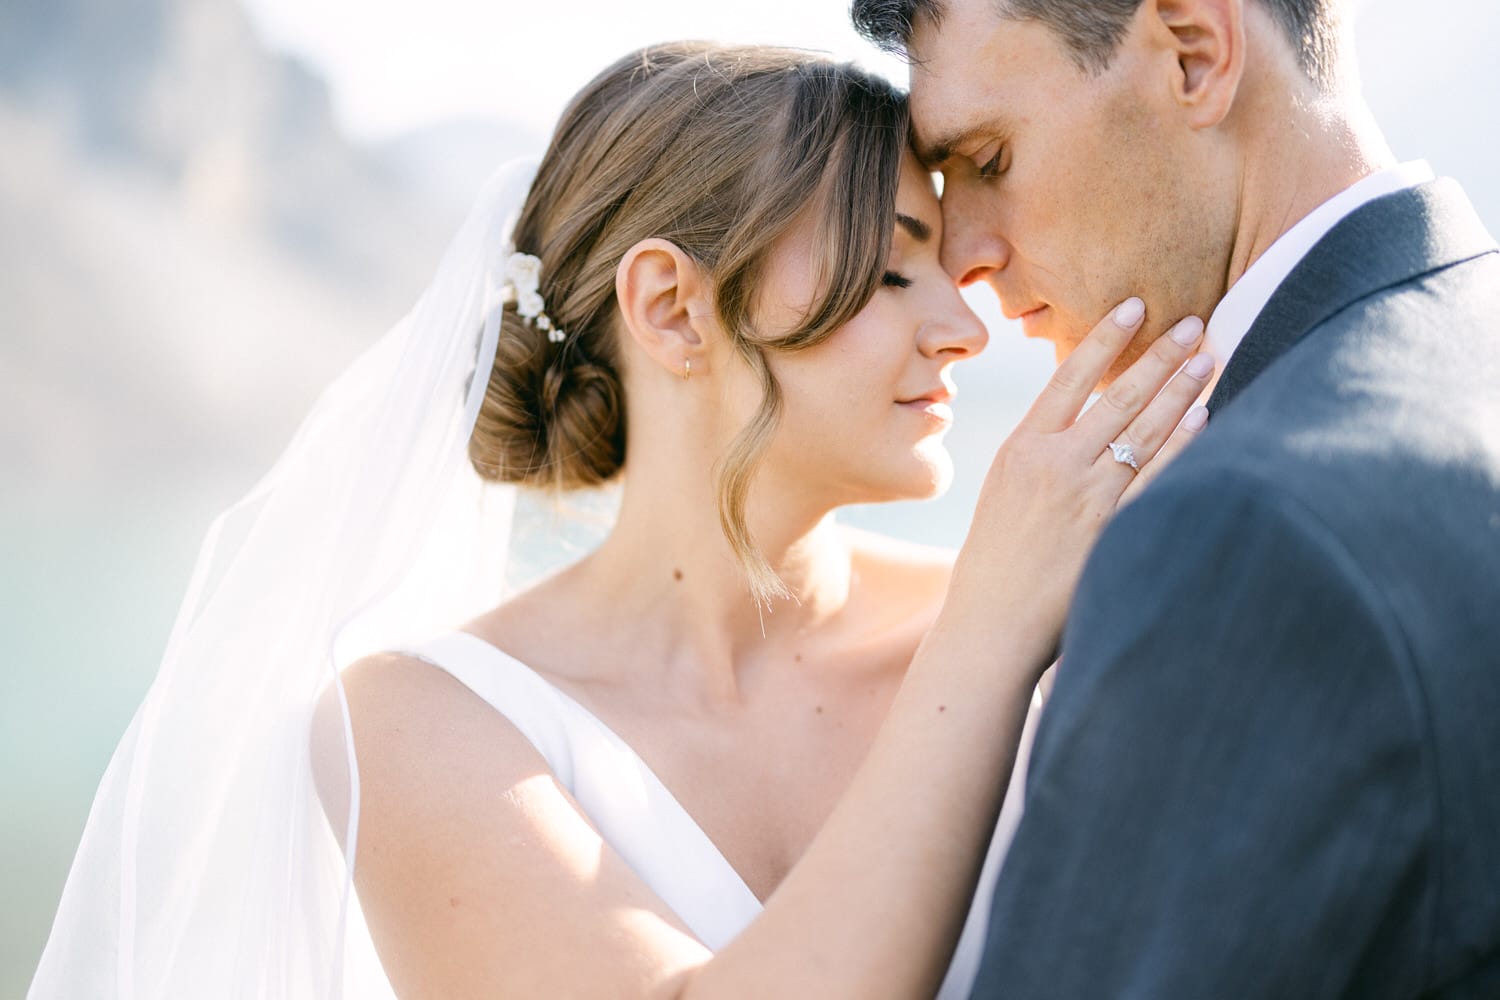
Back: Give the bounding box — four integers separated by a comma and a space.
1146, 0, 1253, 129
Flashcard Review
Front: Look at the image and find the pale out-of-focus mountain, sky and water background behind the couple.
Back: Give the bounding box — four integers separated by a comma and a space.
0, 0, 1500, 999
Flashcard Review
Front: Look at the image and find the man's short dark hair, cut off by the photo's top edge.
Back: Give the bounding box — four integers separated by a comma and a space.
849, 0, 1340, 87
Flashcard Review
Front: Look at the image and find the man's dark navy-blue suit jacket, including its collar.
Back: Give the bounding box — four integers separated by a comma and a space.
974, 180, 1500, 1000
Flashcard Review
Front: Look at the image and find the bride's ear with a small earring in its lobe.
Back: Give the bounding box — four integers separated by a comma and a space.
615, 238, 714, 376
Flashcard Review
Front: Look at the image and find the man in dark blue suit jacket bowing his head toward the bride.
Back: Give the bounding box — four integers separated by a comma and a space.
854, 0, 1500, 1000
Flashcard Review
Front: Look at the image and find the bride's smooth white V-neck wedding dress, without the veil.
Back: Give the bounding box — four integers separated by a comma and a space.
399, 631, 1041, 1000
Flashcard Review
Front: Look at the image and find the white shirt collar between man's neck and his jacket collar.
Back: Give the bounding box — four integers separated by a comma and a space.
1205, 160, 1433, 372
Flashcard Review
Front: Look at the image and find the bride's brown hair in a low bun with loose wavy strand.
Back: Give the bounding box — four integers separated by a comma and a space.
470, 42, 908, 600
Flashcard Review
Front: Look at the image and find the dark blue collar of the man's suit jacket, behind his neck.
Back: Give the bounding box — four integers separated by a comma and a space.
1208, 178, 1497, 412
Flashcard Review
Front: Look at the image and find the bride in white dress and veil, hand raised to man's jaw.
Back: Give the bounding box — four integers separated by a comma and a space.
30, 43, 1205, 1000
